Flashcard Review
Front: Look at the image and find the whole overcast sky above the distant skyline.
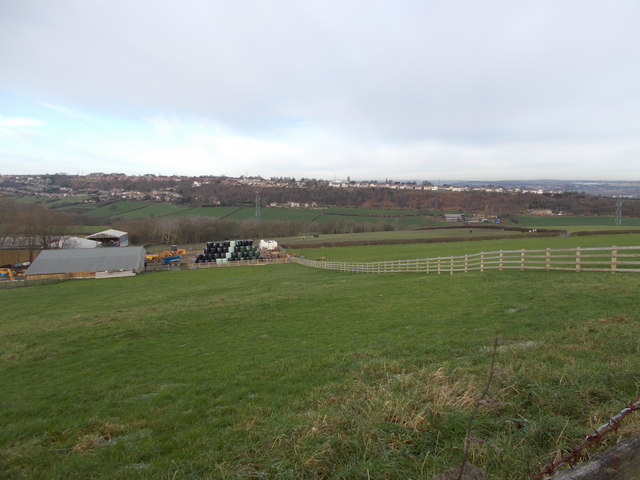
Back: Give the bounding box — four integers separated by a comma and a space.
0, 0, 640, 180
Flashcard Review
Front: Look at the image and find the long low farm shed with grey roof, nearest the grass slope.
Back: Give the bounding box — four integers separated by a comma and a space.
25, 247, 146, 280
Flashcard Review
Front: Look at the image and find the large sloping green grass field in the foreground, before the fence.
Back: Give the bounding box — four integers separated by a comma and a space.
0, 235, 640, 479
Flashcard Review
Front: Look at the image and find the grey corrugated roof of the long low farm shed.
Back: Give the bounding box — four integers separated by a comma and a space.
25, 247, 146, 275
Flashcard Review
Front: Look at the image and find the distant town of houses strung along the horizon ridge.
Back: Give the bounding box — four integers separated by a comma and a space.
0, 173, 640, 206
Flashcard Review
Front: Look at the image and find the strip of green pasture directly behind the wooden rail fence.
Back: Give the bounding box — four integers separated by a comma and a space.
289, 230, 640, 262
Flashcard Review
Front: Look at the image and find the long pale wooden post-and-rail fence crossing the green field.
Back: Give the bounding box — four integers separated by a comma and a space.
289, 246, 640, 275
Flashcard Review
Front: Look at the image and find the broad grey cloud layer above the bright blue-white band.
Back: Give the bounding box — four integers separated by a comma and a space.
0, 0, 640, 146
